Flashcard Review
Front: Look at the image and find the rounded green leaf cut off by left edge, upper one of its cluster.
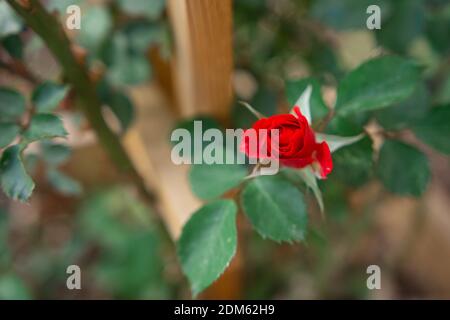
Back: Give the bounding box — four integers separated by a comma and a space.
0, 87, 25, 121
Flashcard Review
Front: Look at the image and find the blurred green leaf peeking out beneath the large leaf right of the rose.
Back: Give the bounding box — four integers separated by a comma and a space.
374, 83, 430, 130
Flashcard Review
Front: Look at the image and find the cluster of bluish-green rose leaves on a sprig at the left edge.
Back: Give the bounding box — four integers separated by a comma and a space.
0, 82, 71, 201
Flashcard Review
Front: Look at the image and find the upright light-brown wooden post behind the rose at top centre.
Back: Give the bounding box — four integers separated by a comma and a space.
167, 0, 233, 122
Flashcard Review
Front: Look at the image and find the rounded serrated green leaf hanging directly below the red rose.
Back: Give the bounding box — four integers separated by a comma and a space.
241, 175, 308, 242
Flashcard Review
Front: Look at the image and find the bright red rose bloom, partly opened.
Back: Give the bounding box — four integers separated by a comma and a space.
241, 106, 333, 178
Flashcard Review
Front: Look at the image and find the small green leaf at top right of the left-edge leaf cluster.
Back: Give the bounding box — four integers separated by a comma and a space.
31, 82, 69, 112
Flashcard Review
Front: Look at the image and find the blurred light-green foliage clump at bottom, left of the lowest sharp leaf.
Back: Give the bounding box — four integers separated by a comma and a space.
78, 188, 168, 299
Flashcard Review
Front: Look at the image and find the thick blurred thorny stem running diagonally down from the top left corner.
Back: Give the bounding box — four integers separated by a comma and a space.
6, 0, 158, 203
